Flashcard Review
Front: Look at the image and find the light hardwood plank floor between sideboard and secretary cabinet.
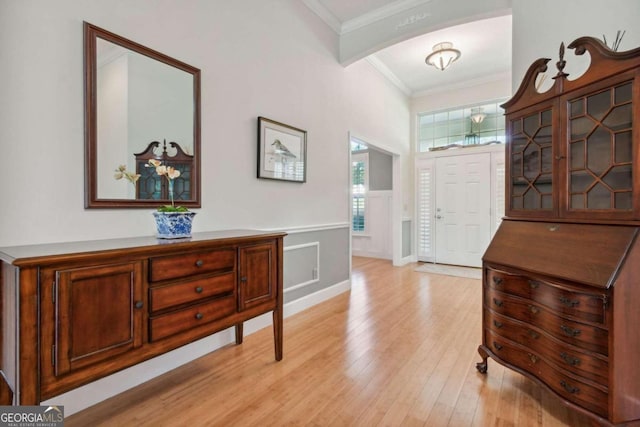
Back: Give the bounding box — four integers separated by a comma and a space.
65, 257, 589, 427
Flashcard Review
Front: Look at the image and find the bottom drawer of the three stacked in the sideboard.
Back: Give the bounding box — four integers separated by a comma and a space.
149, 295, 236, 342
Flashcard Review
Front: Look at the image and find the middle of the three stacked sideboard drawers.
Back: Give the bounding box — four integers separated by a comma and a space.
149, 272, 236, 313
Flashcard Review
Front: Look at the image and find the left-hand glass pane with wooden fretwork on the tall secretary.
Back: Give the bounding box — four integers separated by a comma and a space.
509, 108, 554, 213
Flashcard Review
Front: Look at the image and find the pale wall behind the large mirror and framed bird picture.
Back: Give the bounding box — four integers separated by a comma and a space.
0, 0, 409, 246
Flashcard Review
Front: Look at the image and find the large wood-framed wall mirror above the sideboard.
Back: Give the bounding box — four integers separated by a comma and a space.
84, 22, 200, 208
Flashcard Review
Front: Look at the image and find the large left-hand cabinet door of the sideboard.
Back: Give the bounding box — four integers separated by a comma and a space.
52, 262, 144, 376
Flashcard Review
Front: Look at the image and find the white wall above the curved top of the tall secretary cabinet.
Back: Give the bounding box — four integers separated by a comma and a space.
512, 0, 640, 92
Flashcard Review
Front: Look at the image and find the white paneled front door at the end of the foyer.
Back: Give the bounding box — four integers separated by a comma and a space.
435, 153, 491, 267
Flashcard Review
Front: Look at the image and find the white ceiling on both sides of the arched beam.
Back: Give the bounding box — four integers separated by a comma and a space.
303, 0, 511, 96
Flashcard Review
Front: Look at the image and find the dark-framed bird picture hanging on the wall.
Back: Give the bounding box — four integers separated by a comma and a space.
258, 117, 307, 182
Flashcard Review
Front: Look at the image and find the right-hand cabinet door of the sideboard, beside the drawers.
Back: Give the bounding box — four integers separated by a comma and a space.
238, 242, 277, 311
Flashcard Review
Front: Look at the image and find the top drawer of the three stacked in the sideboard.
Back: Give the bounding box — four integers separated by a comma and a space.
149, 248, 236, 282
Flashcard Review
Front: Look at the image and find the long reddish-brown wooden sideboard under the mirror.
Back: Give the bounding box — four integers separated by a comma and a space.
0, 230, 285, 405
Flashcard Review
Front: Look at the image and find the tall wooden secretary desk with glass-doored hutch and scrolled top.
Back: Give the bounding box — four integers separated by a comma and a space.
477, 37, 640, 426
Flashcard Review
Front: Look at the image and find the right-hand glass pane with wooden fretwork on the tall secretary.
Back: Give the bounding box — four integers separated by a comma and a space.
567, 82, 633, 213
